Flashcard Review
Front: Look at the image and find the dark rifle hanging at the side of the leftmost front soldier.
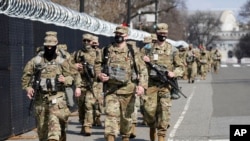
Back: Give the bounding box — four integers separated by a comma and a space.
29, 67, 42, 116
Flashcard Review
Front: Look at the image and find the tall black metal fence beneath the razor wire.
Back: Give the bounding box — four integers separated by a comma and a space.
0, 14, 116, 140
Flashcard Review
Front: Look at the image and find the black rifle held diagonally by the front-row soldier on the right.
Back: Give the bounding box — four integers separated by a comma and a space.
146, 62, 187, 98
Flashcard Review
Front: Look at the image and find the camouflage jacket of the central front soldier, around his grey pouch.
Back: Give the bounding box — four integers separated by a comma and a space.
95, 44, 148, 94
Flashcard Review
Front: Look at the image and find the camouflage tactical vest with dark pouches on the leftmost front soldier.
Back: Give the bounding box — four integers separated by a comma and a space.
34, 52, 65, 93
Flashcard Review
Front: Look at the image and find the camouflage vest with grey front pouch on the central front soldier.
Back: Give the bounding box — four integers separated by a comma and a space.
103, 44, 138, 85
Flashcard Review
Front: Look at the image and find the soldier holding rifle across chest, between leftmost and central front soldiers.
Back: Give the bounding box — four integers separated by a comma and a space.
72, 33, 98, 136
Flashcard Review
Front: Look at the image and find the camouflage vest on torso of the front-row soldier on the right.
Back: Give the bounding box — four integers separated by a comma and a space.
149, 42, 177, 80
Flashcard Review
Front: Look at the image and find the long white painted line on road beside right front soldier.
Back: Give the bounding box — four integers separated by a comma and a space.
168, 86, 196, 141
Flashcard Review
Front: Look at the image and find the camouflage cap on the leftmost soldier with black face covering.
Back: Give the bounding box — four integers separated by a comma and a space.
43, 31, 58, 46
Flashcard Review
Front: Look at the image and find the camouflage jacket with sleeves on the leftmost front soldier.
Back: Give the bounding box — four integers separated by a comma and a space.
22, 52, 81, 89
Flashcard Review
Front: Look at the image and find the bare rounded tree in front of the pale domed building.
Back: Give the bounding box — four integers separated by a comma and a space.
187, 11, 221, 47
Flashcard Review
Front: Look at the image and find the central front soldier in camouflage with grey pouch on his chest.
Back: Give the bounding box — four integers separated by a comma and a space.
95, 26, 148, 141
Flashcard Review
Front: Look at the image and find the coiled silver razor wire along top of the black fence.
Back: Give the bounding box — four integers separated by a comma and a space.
0, 0, 150, 40
